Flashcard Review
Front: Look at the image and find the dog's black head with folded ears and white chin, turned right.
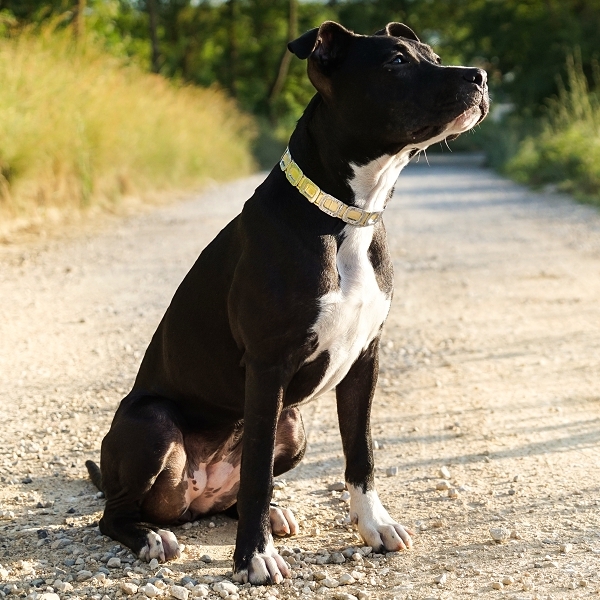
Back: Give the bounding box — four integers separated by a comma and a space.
288, 21, 489, 153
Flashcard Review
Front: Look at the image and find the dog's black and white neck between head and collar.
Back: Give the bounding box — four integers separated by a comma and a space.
290, 94, 413, 212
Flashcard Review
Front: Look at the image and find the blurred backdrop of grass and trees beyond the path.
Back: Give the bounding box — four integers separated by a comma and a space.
0, 0, 600, 232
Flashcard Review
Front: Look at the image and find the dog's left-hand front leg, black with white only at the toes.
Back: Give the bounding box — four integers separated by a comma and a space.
233, 363, 290, 585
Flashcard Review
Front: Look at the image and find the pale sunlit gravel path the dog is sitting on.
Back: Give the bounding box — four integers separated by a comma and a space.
0, 163, 600, 600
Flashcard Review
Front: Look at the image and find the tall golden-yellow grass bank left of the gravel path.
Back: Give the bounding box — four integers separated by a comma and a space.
0, 31, 254, 231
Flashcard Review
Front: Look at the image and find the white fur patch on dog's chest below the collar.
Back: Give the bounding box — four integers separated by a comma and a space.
307, 225, 391, 398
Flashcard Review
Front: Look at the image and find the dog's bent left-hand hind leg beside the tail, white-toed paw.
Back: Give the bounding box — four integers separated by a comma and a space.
95, 397, 187, 561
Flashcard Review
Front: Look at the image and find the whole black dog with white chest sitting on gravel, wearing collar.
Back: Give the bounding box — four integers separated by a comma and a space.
88, 22, 488, 584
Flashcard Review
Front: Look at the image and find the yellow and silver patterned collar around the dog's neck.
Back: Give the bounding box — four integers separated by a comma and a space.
279, 148, 383, 227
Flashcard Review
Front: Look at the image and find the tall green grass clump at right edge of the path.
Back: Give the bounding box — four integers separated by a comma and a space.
506, 54, 600, 203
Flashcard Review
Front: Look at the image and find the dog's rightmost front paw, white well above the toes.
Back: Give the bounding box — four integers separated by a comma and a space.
347, 484, 412, 552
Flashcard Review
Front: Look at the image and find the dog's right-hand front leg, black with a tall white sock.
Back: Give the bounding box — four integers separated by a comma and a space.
336, 338, 412, 551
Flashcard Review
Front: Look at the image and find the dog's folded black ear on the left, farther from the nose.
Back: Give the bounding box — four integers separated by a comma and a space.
288, 21, 354, 69
